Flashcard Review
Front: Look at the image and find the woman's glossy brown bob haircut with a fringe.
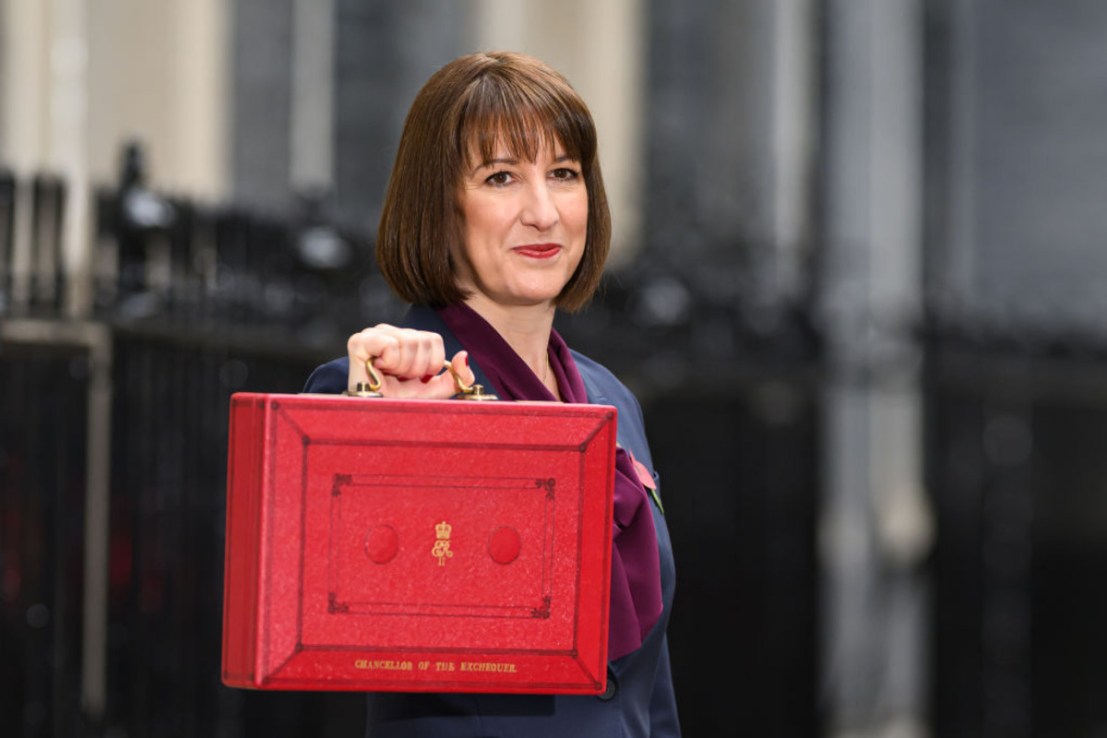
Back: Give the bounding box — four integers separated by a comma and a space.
376, 52, 611, 311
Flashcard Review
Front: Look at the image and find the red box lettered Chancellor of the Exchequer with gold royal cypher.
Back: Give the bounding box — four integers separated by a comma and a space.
223, 393, 617, 694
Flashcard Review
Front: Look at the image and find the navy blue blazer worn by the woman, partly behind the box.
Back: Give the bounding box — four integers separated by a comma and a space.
304, 305, 681, 738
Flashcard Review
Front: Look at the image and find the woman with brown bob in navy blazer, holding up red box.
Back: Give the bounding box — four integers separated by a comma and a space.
306, 52, 680, 738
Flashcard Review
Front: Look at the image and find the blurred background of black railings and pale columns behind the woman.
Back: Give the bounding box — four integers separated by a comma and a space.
0, 0, 1107, 738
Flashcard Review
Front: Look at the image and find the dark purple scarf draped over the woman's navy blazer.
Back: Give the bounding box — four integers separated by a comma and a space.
437, 303, 662, 661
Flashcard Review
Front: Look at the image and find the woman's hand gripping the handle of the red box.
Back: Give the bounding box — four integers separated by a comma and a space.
346, 323, 476, 399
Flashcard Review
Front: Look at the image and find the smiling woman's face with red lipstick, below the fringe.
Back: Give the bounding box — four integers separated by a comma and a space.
458, 137, 588, 305
